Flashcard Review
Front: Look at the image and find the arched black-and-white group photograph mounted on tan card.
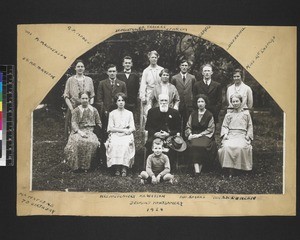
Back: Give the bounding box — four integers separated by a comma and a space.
29, 28, 285, 194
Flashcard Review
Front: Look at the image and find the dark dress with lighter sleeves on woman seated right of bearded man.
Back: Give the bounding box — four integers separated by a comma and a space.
186, 110, 217, 165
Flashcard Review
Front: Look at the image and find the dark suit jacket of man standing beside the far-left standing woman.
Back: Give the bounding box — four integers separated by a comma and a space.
96, 79, 127, 114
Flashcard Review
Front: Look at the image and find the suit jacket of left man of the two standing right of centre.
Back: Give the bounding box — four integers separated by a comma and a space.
171, 73, 196, 111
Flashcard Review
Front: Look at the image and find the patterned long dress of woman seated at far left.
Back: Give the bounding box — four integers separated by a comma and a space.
65, 105, 101, 170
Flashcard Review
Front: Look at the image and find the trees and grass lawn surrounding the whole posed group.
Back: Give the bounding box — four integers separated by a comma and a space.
32, 31, 284, 194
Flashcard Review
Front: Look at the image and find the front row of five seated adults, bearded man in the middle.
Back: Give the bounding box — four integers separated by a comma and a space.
65, 89, 253, 182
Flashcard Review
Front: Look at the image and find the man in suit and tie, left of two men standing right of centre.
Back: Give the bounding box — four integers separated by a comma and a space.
171, 59, 196, 136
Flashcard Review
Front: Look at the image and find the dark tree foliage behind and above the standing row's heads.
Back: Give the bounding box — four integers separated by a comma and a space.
43, 30, 282, 114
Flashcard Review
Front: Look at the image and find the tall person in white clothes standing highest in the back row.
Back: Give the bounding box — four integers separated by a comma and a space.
140, 51, 163, 129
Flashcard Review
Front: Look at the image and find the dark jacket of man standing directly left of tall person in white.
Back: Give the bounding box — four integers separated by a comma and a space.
117, 72, 140, 104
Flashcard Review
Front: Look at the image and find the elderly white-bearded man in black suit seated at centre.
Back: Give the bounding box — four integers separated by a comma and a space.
145, 94, 180, 155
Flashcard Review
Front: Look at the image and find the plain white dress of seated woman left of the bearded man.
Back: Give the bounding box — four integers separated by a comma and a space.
105, 109, 135, 167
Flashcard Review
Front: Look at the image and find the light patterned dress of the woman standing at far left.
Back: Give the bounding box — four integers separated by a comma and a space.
63, 76, 95, 136
